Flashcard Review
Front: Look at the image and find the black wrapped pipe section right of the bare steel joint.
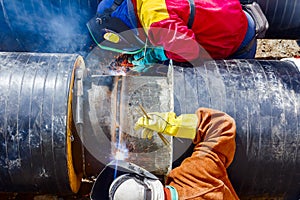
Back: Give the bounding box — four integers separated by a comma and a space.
173, 60, 300, 199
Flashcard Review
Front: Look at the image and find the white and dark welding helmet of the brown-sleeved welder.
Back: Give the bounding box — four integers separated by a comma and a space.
91, 160, 164, 200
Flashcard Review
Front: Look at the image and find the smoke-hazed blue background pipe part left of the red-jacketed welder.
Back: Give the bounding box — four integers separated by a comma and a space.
0, 0, 97, 53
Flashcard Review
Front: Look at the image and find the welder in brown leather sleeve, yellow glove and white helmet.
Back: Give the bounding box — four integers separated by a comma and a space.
91, 108, 239, 200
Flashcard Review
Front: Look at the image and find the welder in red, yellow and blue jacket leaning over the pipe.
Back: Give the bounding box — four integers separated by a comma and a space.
87, 0, 266, 68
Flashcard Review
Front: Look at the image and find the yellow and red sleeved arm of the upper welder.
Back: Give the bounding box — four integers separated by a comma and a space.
136, 0, 203, 62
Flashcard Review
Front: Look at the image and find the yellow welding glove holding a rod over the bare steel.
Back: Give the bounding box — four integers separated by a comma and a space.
134, 112, 198, 139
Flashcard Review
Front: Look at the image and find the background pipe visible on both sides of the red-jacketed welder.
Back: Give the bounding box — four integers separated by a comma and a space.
0, 0, 300, 55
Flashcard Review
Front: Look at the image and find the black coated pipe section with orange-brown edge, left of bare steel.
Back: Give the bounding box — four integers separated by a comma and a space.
0, 51, 84, 194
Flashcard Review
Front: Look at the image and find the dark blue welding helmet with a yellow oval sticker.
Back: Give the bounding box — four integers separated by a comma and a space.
86, 14, 145, 54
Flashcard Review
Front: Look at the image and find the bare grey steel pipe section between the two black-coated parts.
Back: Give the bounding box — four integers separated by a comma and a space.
80, 60, 173, 176
